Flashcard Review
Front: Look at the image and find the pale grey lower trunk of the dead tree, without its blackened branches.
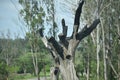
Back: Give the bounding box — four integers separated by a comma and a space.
51, 39, 79, 80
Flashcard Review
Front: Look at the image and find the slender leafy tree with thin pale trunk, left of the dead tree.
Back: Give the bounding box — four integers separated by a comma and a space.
19, 0, 48, 80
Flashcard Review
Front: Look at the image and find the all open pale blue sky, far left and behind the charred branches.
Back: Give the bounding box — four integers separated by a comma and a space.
0, 0, 76, 38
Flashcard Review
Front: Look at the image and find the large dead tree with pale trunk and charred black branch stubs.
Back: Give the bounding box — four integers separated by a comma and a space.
39, 0, 100, 80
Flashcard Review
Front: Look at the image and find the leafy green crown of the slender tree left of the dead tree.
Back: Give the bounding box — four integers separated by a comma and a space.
19, 0, 45, 31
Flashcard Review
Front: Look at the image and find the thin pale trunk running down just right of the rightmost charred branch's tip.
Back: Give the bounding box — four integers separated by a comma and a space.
101, 20, 108, 80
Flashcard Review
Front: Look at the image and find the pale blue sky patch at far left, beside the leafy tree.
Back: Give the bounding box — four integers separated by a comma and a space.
0, 0, 25, 38
